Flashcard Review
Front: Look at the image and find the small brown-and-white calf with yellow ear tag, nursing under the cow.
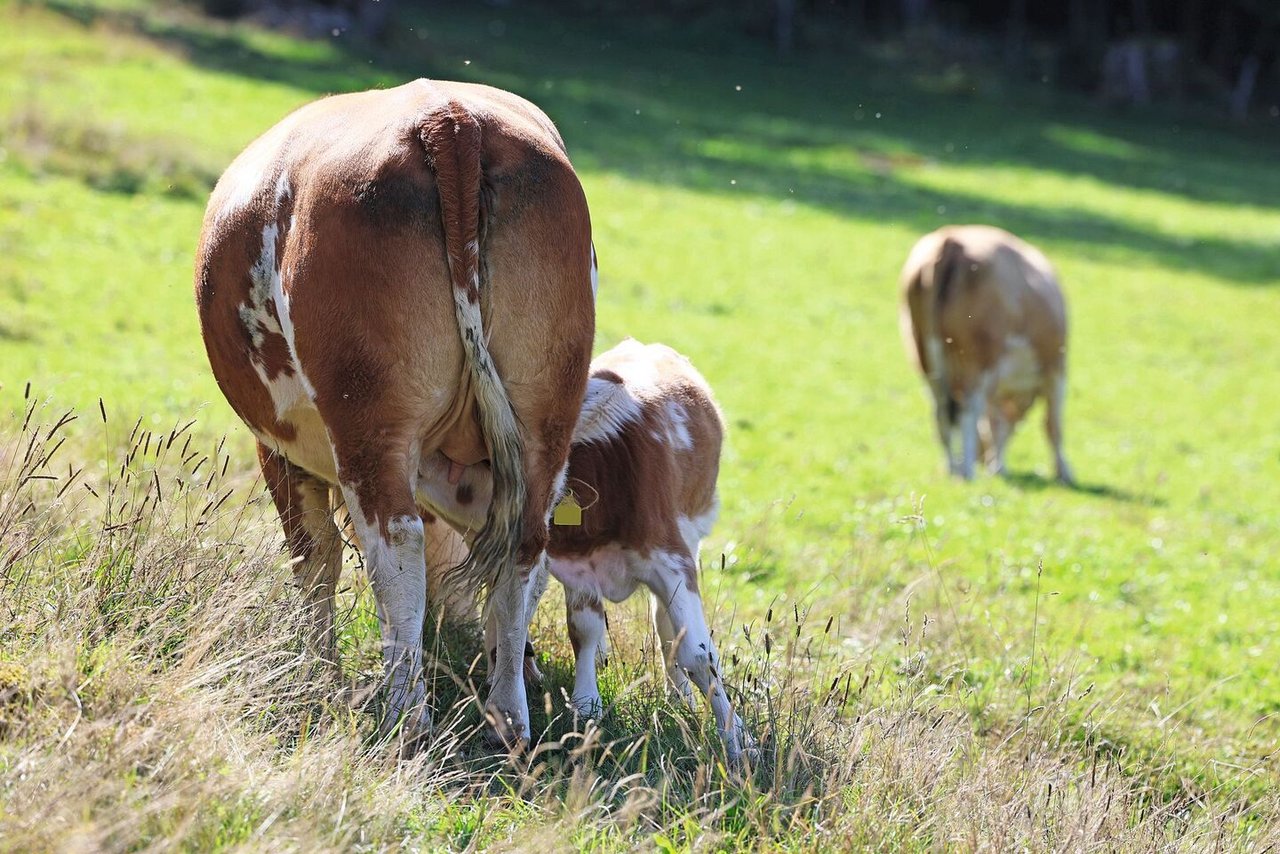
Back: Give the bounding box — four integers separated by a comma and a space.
419, 339, 750, 759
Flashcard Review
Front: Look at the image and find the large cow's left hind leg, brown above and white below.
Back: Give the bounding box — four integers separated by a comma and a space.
337, 448, 431, 744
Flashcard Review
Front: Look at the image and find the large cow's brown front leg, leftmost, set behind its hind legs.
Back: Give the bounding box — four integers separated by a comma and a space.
257, 442, 342, 668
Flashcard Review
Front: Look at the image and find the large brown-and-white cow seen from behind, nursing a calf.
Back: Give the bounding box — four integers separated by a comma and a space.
196, 79, 595, 739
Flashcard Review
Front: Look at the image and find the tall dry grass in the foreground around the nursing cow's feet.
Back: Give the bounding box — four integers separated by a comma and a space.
0, 405, 1280, 851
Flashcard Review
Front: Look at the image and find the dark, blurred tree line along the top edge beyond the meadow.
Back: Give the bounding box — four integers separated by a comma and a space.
198, 0, 1280, 118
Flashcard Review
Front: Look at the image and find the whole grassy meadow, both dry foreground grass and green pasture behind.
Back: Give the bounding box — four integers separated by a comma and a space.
0, 0, 1280, 850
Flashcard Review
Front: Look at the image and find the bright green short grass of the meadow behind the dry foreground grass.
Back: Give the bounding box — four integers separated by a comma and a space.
0, 1, 1280, 845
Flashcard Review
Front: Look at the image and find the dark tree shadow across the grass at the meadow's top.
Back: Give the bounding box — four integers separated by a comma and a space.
37, 0, 1280, 286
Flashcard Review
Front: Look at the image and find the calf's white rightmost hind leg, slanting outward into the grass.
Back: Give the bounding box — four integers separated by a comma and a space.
645, 549, 750, 762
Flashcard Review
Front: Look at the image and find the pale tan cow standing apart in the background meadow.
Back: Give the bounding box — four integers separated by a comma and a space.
901, 225, 1073, 483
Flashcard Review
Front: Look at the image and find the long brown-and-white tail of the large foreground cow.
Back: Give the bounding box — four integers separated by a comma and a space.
420, 100, 527, 592
